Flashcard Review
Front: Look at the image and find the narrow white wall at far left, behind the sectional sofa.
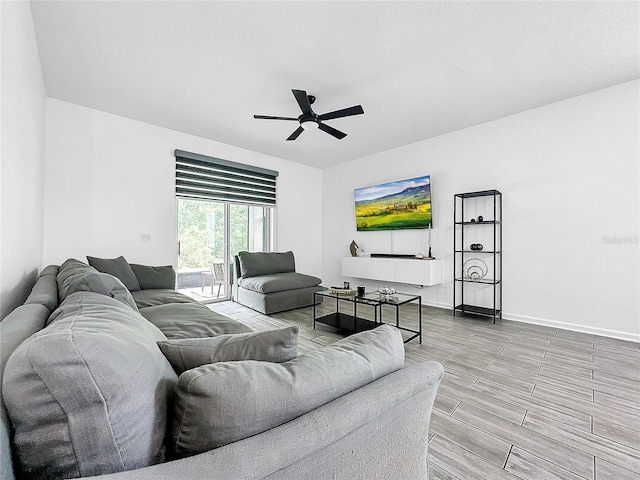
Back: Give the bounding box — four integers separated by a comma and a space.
0, 2, 46, 318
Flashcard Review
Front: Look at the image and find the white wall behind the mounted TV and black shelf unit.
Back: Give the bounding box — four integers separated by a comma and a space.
322, 81, 640, 340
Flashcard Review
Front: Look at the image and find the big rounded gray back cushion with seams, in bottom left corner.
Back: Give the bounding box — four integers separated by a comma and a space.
2, 292, 176, 479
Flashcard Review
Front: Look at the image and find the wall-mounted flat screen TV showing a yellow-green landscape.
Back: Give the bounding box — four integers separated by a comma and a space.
353, 175, 431, 232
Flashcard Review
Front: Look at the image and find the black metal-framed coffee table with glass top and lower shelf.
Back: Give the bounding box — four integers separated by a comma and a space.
313, 290, 422, 343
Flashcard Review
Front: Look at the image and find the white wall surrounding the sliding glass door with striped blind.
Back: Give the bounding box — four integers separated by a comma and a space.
44, 99, 322, 276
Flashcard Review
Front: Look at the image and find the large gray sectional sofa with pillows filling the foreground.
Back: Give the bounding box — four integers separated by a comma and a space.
0, 259, 443, 480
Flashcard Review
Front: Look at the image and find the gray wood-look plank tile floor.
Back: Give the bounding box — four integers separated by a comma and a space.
210, 300, 640, 480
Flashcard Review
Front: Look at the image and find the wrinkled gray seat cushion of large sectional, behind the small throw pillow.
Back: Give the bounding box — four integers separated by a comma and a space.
140, 302, 253, 339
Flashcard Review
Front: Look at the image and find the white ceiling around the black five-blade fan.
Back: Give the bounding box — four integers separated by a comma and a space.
32, 1, 640, 168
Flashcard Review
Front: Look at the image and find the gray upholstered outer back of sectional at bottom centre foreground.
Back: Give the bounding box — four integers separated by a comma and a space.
91, 362, 443, 480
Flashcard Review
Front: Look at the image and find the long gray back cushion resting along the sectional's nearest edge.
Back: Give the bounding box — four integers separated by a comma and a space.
171, 325, 404, 455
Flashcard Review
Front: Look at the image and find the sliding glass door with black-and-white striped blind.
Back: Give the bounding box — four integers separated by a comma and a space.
175, 150, 278, 302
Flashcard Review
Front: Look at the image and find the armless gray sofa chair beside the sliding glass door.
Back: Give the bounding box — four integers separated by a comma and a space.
233, 251, 323, 315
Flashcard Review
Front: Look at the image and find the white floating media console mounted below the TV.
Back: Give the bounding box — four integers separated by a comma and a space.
342, 257, 442, 287
